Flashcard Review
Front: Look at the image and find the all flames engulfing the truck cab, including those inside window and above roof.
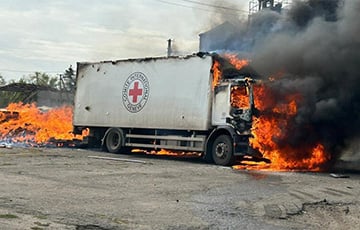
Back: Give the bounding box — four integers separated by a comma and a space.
218, 55, 330, 171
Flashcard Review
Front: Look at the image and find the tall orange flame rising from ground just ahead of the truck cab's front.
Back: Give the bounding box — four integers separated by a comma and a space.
240, 85, 330, 171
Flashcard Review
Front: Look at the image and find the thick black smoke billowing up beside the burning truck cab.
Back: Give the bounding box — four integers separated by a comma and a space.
215, 0, 360, 166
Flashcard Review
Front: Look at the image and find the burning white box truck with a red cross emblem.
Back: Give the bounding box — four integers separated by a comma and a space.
73, 53, 255, 165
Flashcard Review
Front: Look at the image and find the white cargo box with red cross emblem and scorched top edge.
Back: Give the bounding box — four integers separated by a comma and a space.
73, 55, 213, 130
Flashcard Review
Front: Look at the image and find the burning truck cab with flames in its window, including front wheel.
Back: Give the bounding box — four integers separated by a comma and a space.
207, 76, 256, 165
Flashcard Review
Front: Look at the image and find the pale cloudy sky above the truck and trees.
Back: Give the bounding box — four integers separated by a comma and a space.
0, 0, 248, 81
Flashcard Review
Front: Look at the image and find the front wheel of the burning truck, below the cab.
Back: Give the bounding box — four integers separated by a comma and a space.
212, 135, 235, 166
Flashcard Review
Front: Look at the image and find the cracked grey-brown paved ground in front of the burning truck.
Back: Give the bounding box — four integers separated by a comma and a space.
0, 148, 360, 230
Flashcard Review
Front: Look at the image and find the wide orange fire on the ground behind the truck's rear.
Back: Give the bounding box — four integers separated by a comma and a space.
0, 103, 85, 144
